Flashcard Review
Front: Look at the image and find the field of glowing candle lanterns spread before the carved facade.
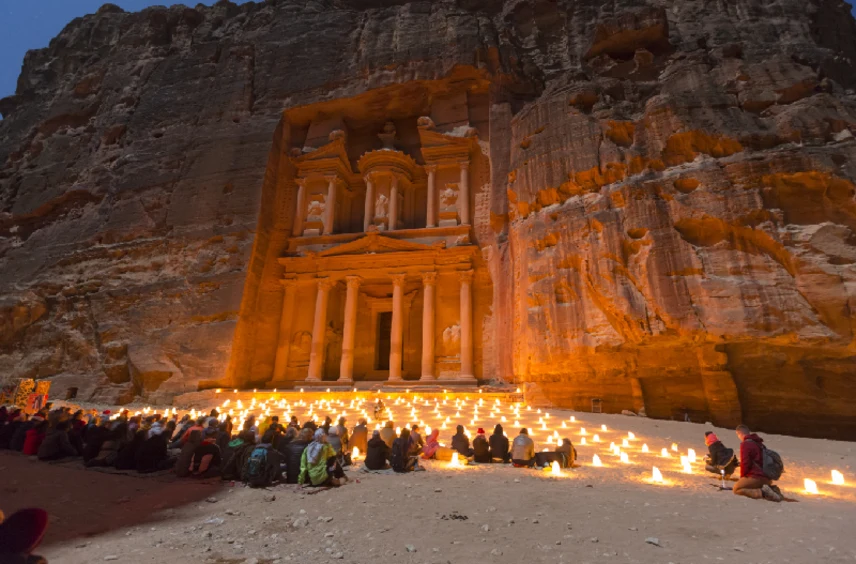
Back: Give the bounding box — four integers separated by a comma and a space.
125, 390, 846, 494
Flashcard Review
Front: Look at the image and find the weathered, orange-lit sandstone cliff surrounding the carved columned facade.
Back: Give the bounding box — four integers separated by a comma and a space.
0, 0, 856, 437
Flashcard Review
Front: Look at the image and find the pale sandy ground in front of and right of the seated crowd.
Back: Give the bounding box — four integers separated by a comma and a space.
0, 411, 856, 564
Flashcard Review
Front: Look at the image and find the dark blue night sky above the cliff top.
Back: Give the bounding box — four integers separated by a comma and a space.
0, 0, 852, 98
